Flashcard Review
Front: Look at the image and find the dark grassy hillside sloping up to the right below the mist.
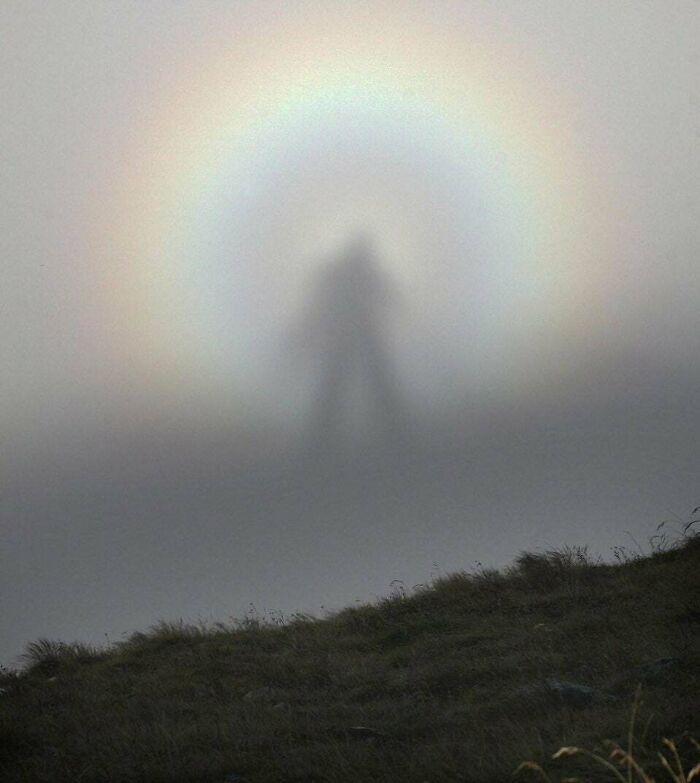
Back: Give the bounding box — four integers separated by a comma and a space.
0, 536, 700, 783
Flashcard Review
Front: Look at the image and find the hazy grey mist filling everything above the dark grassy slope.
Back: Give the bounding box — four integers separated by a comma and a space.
0, 0, 700, 663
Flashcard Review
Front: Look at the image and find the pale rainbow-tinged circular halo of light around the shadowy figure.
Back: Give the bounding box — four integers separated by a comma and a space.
93, 4, 602, 420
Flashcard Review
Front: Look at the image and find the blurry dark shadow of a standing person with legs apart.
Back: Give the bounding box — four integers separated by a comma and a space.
296, 235, 407, 452
